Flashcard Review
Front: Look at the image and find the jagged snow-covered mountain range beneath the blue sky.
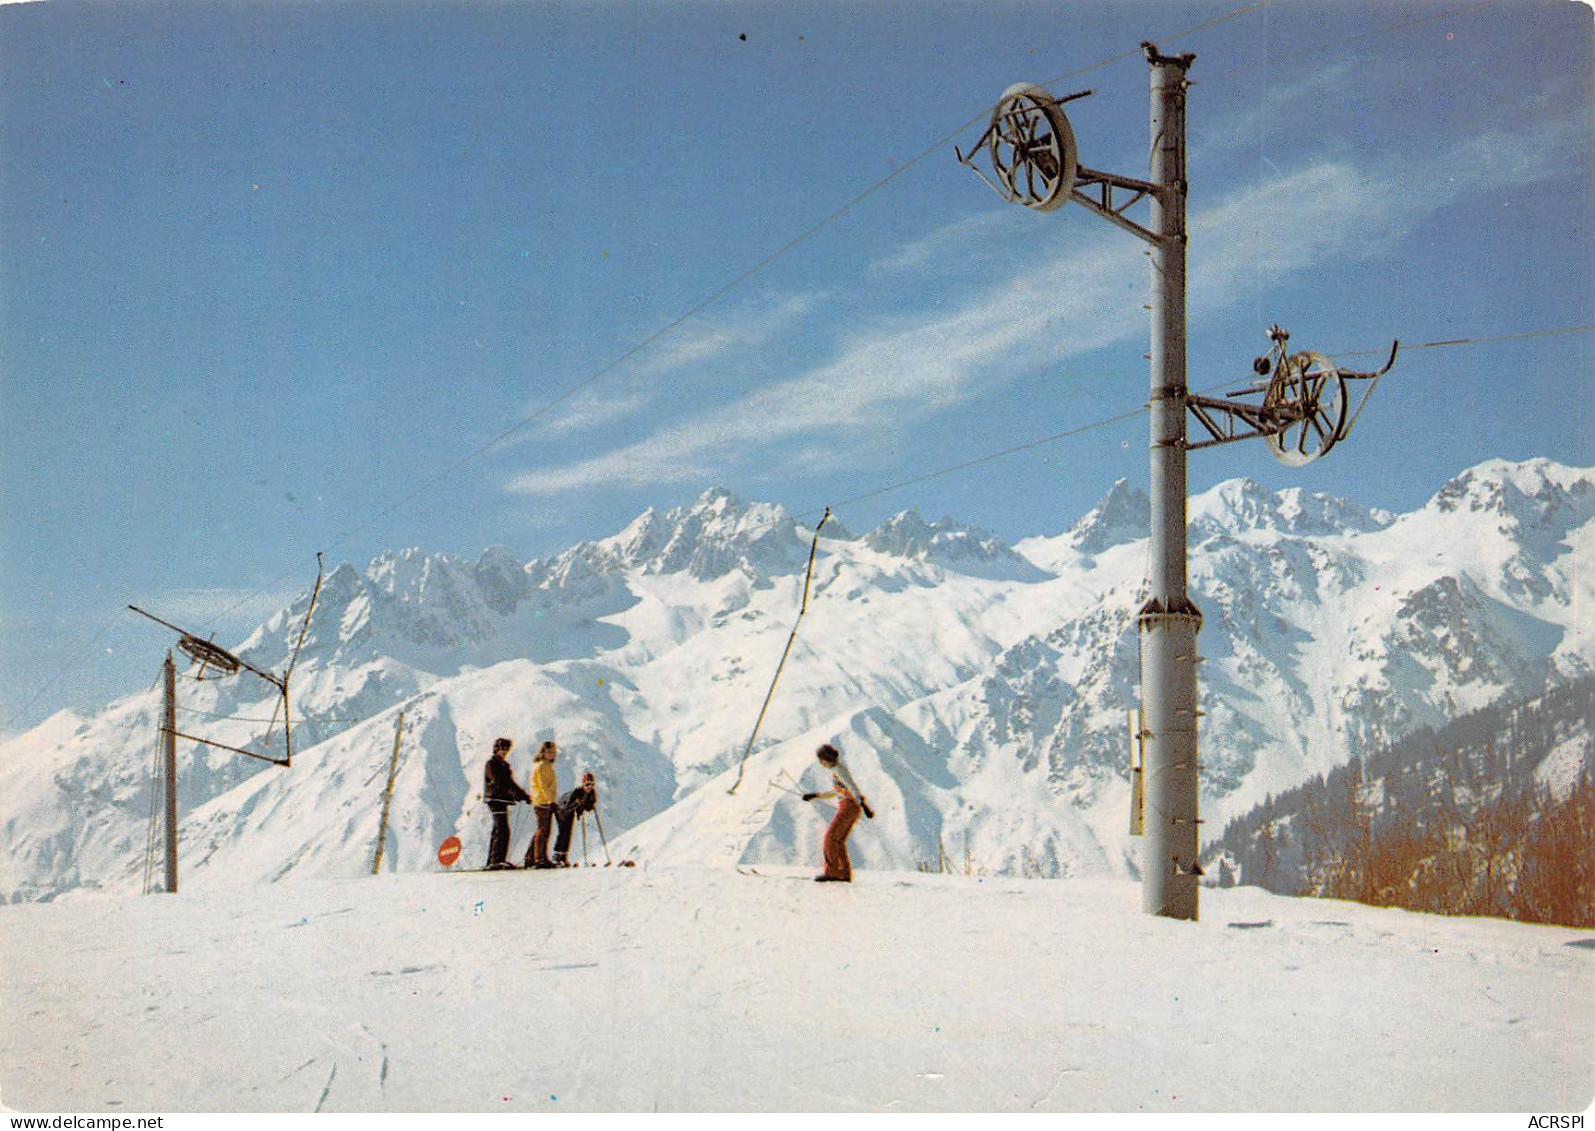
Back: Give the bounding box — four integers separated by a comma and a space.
0, 459, 1595, 900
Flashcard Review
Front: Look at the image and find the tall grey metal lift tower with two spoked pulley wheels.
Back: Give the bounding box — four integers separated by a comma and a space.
959, 43, 1396, 919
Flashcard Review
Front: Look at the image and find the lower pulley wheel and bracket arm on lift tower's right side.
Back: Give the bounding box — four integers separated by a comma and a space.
1185, 325, 1400, 467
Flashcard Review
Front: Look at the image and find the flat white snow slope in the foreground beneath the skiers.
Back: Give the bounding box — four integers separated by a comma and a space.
0, 868, 1595, 1113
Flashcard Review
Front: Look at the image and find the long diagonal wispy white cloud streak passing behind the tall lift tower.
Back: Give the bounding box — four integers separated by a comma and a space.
509, 111, 1584, 496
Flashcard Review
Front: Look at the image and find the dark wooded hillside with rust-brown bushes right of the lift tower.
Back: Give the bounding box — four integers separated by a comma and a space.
1207, 678, 1595, 927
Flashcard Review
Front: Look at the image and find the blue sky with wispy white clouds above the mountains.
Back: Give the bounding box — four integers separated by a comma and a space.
0, 0, 1595, 727
